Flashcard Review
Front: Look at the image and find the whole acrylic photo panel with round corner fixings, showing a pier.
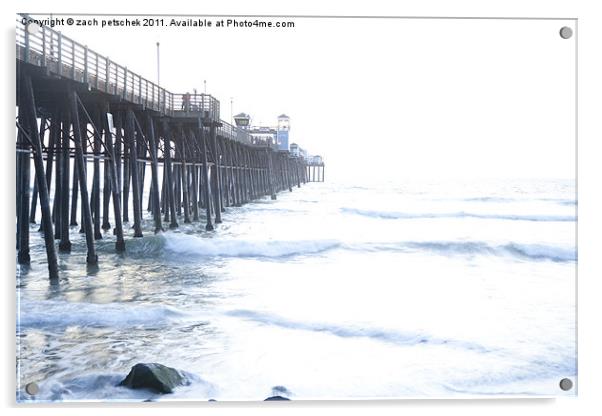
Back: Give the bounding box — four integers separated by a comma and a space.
15, 14, 577, 402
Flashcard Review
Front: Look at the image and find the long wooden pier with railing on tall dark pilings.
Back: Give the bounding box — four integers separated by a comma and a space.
16, 16, 324, 280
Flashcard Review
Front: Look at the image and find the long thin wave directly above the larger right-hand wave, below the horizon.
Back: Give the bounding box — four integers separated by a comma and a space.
340, 207, 575, 222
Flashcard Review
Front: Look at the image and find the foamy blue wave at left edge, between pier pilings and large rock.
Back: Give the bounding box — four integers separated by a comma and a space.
17, 300, 186, 328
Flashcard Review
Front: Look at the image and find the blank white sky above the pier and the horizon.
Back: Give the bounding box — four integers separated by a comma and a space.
31, 16, 575, 180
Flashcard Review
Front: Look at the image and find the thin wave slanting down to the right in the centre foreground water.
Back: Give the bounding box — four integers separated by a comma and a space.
226, 309, 489, 352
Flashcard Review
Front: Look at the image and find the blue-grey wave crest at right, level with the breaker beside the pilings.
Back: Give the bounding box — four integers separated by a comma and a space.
366, 241, 577, 263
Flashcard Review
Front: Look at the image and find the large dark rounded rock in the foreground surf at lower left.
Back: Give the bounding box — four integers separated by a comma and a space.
119, 363, 188, 393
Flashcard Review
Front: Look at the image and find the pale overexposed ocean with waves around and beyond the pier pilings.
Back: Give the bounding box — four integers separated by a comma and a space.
16, 180, 577, 401
